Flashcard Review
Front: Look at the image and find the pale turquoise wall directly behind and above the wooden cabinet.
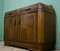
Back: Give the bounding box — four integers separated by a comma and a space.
3, 0, 60, 49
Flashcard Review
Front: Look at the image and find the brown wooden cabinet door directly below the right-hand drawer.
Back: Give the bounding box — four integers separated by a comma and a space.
20, 13, 37, 43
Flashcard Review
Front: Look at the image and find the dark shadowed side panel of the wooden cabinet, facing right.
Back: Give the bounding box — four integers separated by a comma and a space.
44, 11, 56, 48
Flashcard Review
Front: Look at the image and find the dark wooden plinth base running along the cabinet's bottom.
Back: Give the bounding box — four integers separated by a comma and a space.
4, 41, 54, 51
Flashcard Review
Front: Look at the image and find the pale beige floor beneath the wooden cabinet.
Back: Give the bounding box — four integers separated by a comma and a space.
0, 41, 60, 51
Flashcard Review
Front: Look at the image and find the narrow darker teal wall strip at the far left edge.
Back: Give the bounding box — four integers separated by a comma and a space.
0, 0, 3, 40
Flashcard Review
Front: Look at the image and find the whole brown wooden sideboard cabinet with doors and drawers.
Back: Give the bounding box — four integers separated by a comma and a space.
4, 3, 56, 51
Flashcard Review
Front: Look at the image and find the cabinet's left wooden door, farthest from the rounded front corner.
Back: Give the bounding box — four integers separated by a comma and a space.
4, 17, 16, 41
